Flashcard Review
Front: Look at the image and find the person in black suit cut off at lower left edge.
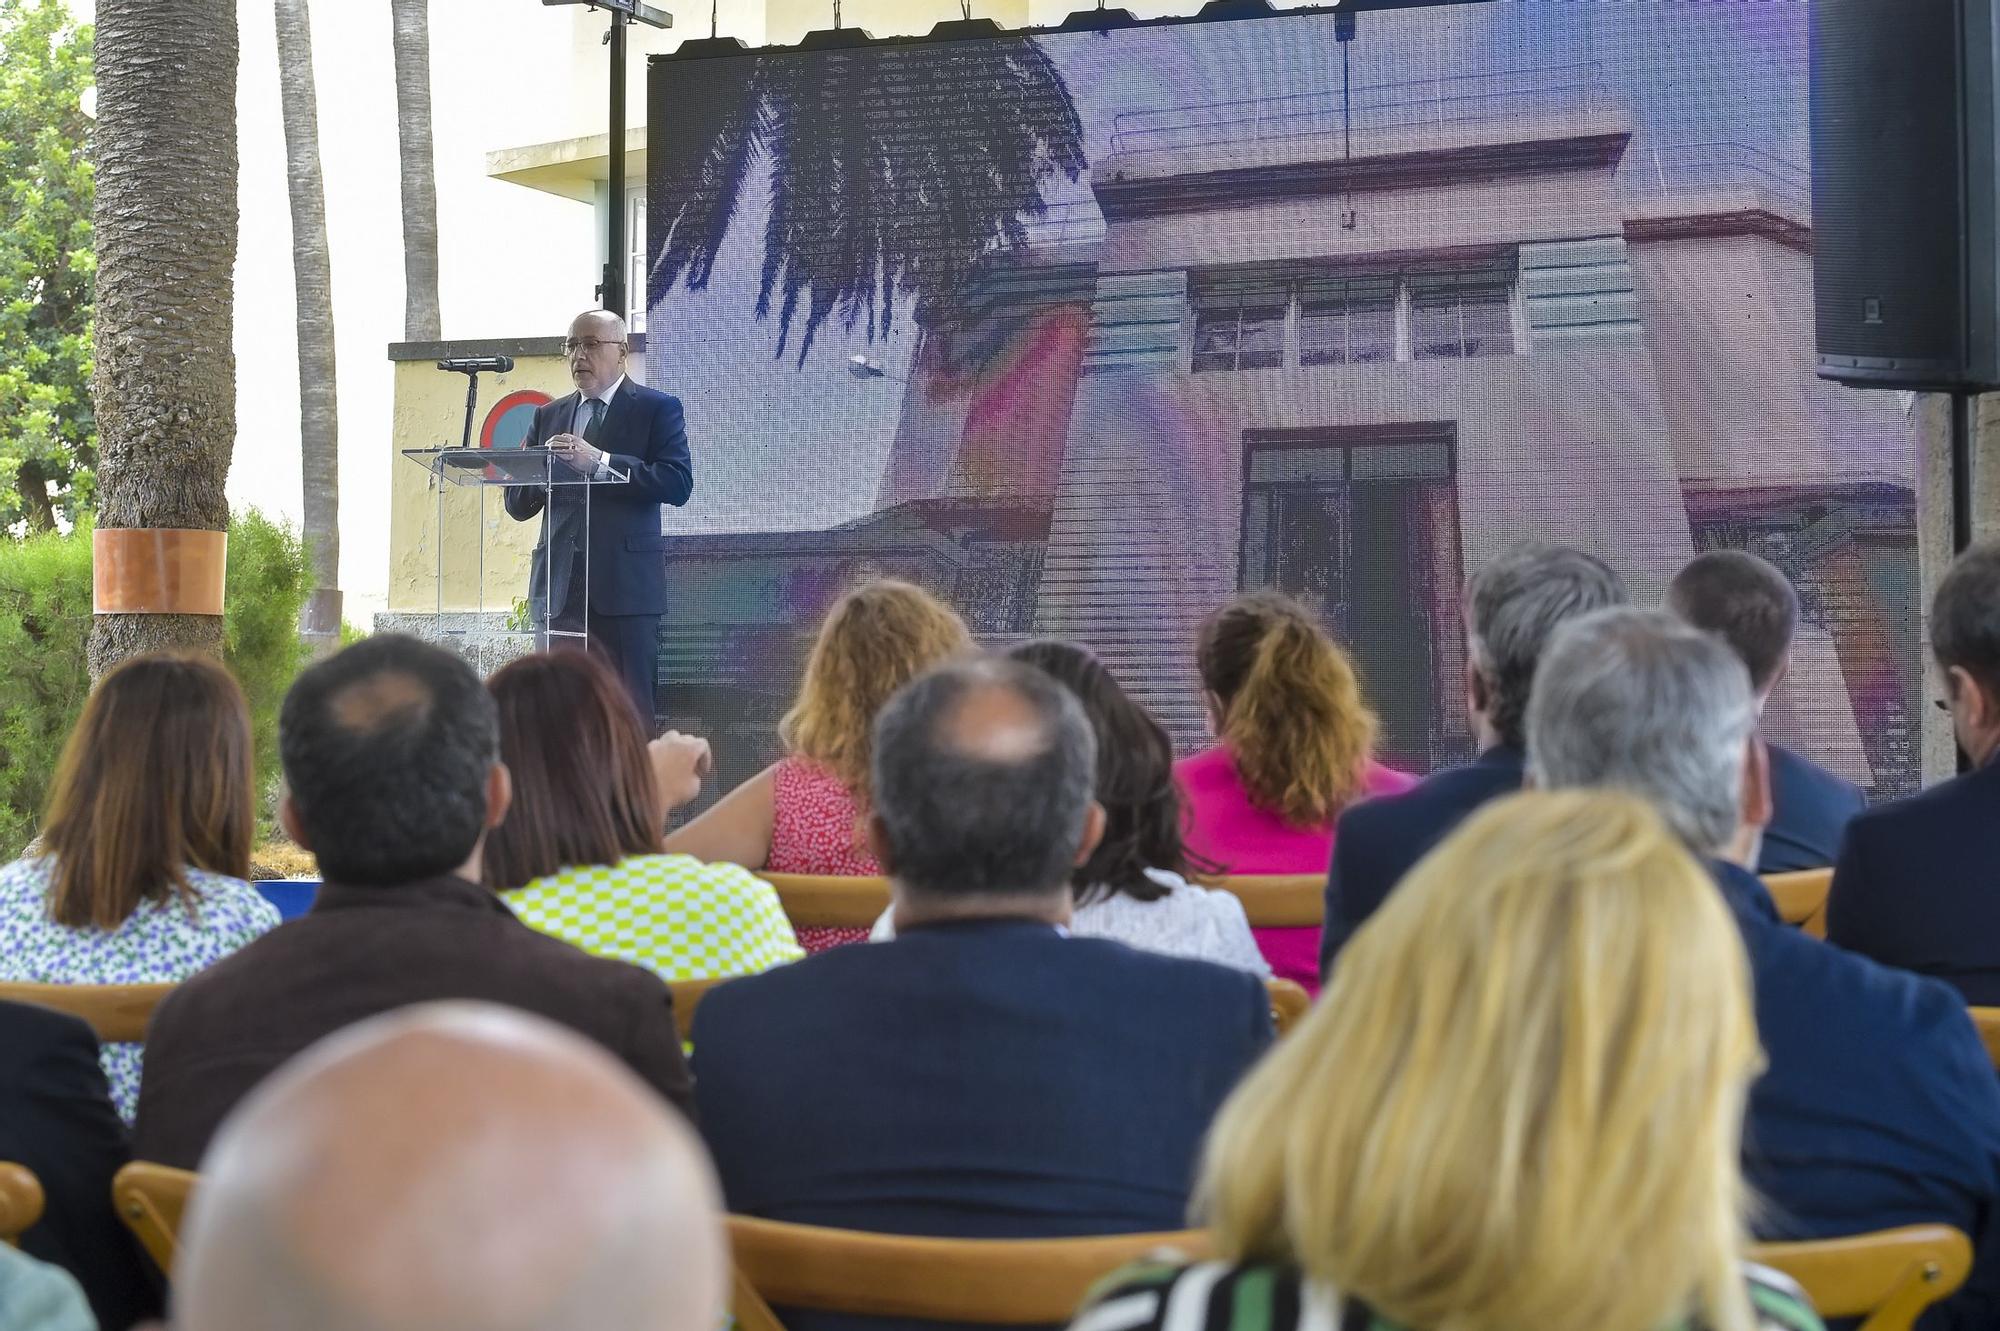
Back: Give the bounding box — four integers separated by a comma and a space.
0, 1003, 160, 1331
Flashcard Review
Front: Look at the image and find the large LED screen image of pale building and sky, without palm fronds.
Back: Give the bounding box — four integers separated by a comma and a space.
648, 0, 1918, 793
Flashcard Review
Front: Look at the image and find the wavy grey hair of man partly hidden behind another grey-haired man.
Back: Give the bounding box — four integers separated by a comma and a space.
1466, 542, 1626, 747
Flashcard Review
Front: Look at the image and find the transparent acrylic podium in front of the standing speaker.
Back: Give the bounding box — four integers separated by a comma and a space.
402, 448, 632, 675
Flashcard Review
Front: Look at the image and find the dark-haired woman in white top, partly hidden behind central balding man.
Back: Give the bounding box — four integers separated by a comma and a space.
872, 640, 1270, 979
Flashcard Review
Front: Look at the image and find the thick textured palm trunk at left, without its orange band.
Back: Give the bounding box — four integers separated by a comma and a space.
88, 0, 236, 673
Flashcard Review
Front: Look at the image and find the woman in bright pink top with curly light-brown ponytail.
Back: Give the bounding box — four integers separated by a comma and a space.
1174, 592, 1416, 989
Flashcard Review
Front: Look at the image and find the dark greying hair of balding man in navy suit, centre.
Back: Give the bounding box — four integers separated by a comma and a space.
872, 658, 1098, 897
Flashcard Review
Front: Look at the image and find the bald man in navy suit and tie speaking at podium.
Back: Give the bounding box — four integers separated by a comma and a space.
506, 310, 694, 731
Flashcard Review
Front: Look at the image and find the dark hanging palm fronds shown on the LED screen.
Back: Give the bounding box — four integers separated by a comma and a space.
648, 38, 1086, 364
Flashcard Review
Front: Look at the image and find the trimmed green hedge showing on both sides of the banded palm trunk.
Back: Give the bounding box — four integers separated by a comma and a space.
0, 510, 312, 859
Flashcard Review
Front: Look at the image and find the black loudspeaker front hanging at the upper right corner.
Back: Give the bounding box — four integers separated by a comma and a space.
1812, 0, 1968, 373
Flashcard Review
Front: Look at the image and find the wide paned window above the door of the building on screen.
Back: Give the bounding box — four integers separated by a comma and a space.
1190, 252, 1520, 374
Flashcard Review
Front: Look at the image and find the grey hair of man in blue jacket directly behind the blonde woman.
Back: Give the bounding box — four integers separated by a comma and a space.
1528, 608, 1756, 855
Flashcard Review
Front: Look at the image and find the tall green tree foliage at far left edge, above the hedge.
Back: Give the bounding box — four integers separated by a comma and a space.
0, 0, 98, 532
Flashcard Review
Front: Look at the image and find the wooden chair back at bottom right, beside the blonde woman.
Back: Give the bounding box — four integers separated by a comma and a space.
1750, 1225, 1972, 1331
